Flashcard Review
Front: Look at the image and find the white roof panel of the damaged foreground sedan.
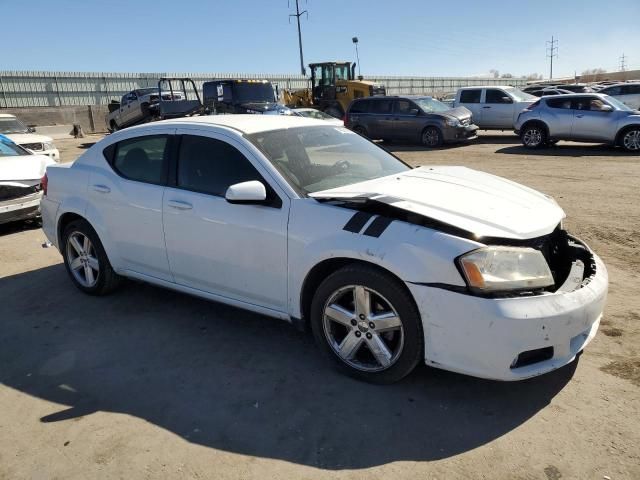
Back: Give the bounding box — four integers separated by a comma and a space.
152, 114, 327, 134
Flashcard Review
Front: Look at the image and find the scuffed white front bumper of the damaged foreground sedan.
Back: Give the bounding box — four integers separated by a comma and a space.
407, 238, 608, 380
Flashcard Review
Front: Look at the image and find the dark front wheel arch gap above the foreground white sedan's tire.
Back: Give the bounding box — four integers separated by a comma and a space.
300, 257, 415, 325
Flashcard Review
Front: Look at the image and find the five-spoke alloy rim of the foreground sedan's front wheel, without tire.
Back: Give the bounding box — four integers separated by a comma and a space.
323, 285, 404, 372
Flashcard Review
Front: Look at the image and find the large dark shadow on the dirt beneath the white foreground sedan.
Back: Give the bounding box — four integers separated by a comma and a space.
0, 264, 576, 470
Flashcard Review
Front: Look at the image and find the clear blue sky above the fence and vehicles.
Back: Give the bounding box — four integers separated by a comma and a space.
0, 0, 640, 77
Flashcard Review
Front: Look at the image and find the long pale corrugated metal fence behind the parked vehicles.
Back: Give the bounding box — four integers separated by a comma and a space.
0, 71, 526, 108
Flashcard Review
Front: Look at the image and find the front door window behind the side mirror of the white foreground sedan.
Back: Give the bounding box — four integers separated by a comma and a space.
178, 135, 266, 197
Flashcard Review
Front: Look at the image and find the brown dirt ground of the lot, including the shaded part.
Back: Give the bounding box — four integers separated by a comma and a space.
0, 134, 640, 480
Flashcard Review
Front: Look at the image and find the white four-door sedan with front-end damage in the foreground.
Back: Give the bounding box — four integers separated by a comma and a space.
42, 115, 608, 383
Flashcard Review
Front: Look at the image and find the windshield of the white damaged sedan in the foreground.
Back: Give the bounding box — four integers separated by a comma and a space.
247, 126, 411, 194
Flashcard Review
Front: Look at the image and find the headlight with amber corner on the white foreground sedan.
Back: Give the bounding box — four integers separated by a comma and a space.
458, 247, 554, 292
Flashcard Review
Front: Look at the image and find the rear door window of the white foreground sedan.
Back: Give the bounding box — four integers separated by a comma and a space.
104, 135, 169, 185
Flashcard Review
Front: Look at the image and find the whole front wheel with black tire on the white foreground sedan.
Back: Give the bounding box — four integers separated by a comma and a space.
311, 264, 424, 384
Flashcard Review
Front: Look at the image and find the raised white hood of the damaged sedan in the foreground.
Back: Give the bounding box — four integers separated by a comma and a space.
310, 167, 565, 240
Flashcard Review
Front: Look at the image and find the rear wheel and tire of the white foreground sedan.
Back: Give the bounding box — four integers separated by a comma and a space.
61, 220, 121, 295
